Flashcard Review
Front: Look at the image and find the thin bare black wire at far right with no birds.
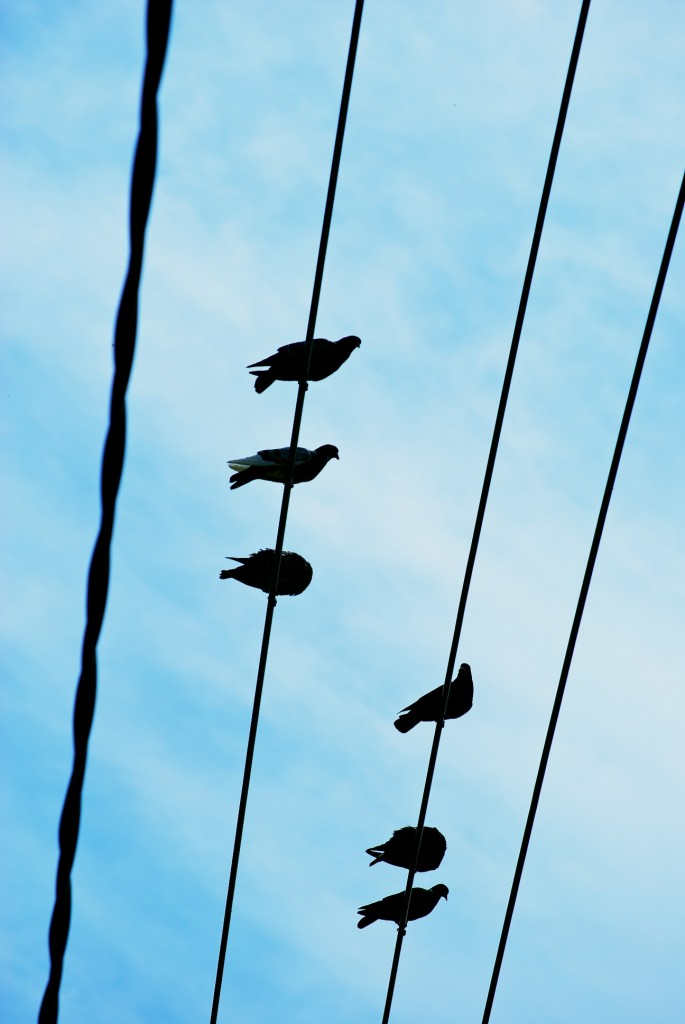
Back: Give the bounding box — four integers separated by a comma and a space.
482, 167, 685, 1024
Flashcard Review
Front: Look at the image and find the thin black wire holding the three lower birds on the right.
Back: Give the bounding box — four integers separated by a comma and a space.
382, 0, 591, 1024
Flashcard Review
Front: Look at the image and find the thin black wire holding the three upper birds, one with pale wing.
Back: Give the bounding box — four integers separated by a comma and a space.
210, 0, 363, 1024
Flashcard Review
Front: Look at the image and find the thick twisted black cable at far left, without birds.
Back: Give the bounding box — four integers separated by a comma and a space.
38, 0, 171, 1024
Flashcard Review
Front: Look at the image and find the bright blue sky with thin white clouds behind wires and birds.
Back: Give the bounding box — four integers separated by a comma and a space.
0, 0, 685, 1024
